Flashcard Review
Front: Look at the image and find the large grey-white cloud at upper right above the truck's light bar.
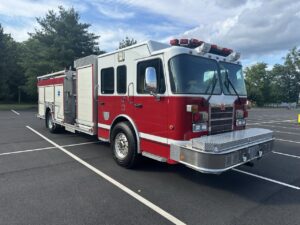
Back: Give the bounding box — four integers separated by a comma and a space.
179, 0, 300, 57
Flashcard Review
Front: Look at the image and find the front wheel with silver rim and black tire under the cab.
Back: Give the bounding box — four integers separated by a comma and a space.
111, 122, 139, 168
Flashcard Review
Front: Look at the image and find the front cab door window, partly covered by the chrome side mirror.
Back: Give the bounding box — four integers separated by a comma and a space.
137, 59, 166, 94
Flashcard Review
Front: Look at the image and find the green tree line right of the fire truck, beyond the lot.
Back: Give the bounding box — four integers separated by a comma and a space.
244, 47, 300, 106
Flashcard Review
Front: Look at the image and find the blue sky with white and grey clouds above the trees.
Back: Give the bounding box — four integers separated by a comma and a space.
0, 0, 300, 68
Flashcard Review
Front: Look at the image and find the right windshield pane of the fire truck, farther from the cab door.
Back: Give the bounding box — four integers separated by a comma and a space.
220, 62, 247, 95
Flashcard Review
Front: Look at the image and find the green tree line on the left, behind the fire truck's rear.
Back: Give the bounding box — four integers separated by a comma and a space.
0, 7, 136, 102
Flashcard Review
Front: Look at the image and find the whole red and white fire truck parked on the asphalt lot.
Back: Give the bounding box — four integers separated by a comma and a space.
37, 39, 274, 174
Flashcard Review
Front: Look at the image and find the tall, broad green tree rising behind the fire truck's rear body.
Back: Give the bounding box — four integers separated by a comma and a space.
22, 6, 101, 97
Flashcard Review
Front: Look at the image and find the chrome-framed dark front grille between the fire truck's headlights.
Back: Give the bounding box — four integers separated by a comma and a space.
210, 107, 233, 134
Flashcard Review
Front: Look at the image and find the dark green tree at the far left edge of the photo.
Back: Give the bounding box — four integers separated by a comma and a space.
0, 24, 24, 102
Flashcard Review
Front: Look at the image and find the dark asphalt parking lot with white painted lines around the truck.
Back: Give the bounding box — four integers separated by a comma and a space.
0, 109, 300, 225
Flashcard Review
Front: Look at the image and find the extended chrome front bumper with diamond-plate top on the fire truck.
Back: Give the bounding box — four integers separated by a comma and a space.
170, 128, 274, 174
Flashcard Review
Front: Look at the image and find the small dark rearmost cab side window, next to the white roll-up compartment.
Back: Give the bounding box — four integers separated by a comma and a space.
101, 67, 115, 94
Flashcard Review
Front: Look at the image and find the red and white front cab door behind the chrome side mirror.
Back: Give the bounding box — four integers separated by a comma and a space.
133, 57, 168, 155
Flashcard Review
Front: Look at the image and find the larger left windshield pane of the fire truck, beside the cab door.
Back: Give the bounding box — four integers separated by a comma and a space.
169, 54, 221, 95
